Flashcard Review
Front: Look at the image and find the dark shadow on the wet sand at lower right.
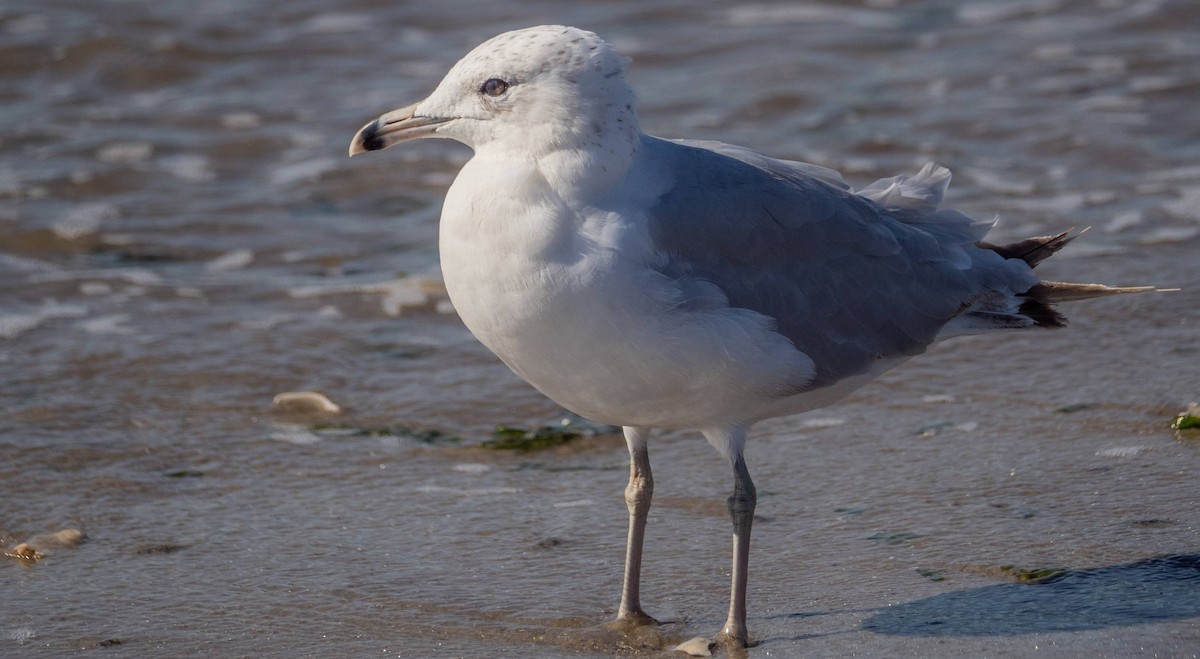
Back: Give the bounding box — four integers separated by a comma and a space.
862, 553, 1200, 636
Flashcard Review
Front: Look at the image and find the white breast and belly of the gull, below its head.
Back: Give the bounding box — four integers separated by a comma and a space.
440, 158, 811, 427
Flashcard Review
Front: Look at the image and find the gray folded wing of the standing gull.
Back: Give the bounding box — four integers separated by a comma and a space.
644, 138, 1037, 388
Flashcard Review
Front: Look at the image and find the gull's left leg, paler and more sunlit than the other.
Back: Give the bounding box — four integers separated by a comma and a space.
617, 426, 658, 624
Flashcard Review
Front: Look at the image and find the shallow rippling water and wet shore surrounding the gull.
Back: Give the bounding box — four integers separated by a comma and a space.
0, 0, 1200, 657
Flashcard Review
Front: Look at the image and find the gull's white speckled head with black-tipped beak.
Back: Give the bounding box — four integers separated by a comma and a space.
350, 25, 640, 156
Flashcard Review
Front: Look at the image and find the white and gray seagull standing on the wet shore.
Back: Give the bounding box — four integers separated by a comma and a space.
349, 25, 1153, 647
